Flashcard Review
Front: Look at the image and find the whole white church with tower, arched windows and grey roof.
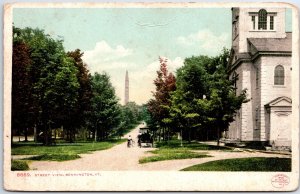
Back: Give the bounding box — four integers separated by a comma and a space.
225, 8, 292, 149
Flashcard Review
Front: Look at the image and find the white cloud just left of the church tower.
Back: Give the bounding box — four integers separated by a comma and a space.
177, 29, 230, 55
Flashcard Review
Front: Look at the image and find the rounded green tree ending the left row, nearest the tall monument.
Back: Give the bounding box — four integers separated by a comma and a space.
91, 73, 121, 140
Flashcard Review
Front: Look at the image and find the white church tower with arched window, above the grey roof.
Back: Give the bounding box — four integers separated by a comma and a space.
232, 7, 286, 53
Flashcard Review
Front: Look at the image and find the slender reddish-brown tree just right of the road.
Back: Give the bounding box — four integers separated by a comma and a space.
147, 57, 176, 140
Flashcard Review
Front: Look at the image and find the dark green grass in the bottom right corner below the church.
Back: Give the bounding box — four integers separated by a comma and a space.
181, 157, 291, 172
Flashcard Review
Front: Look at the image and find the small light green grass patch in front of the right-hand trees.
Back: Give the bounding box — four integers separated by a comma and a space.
139, 148, 210, 163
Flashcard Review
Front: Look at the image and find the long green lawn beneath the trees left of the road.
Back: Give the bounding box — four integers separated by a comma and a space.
11, 139, 126, 161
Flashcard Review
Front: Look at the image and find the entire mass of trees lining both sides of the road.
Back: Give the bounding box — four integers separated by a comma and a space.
12, 27, 247, 147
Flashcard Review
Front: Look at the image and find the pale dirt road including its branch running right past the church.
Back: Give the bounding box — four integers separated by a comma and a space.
30, 124, 290, 171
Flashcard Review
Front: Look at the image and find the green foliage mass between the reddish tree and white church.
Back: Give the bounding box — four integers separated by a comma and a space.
166, 49, 247, 141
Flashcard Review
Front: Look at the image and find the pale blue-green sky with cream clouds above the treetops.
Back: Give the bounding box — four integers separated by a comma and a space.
13, 8, 291, 104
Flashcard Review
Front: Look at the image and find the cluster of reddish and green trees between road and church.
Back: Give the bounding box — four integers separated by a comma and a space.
147, 49, 247, 145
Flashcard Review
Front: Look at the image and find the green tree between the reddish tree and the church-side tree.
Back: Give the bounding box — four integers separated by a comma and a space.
170, 56, 209, 141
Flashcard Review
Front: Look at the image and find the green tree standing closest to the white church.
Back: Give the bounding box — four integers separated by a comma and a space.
198, 49, 248, 145
